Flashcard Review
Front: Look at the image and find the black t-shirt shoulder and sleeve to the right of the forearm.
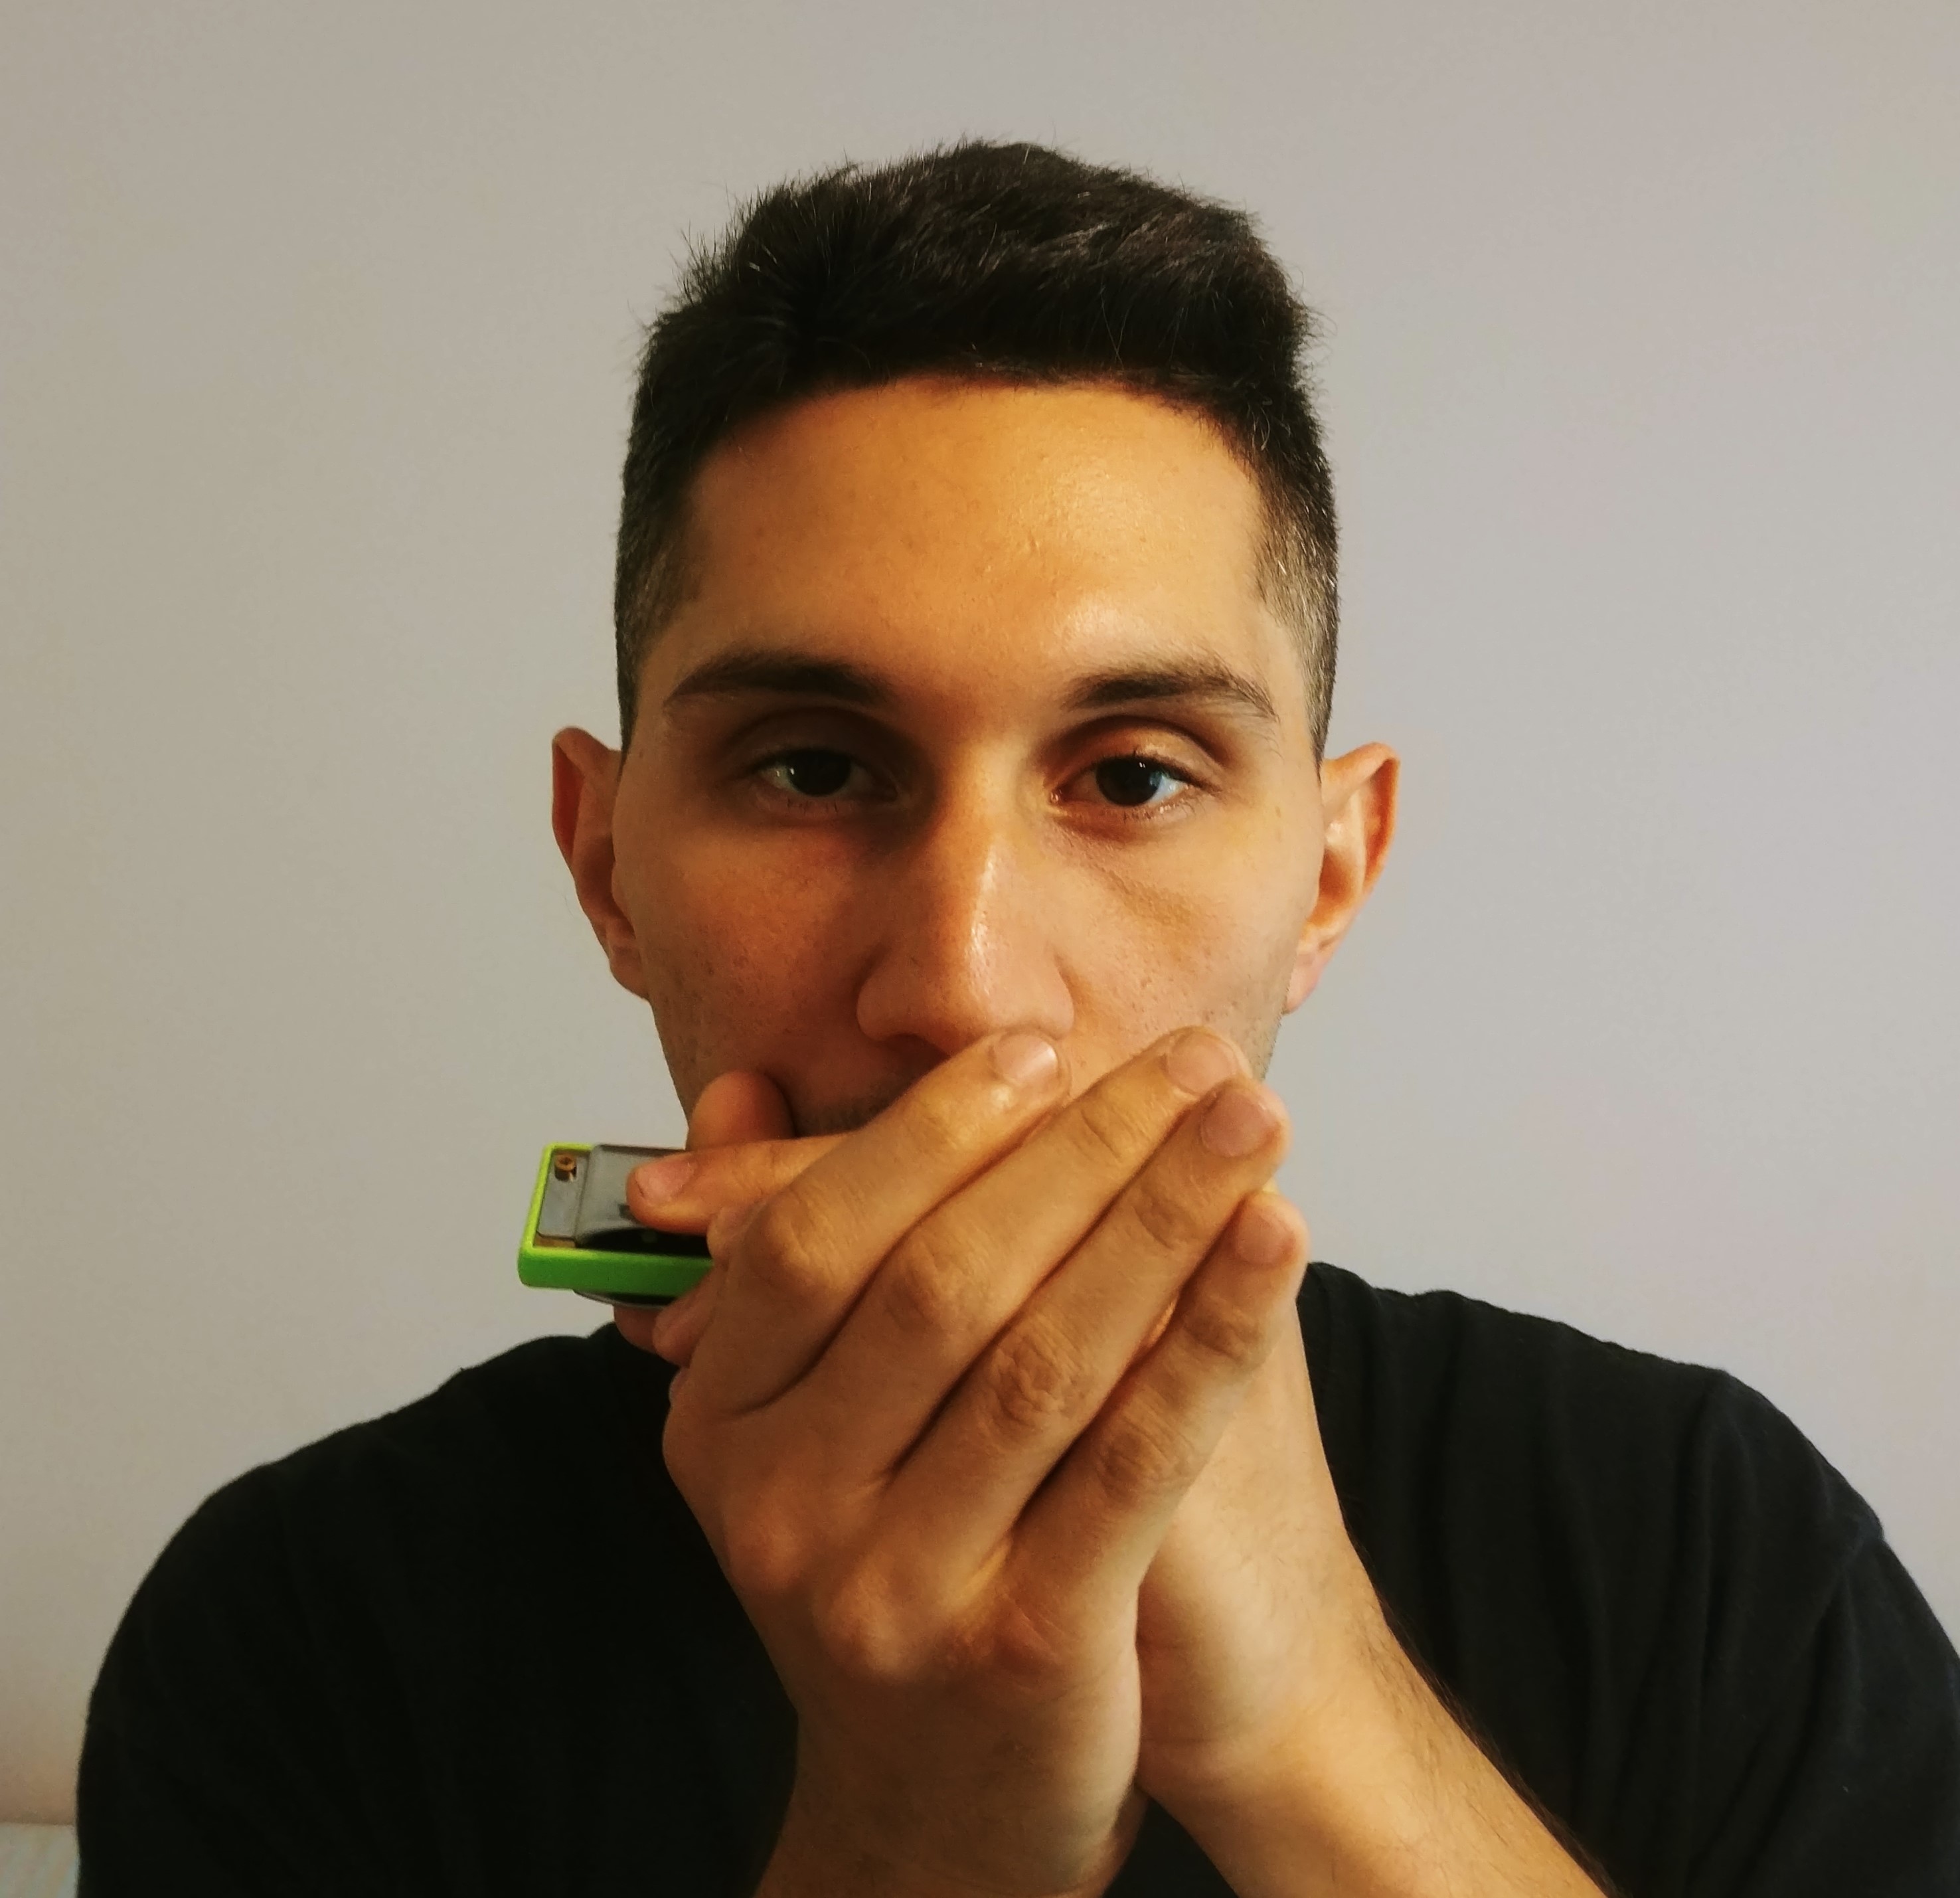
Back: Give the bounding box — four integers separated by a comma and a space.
1301, 1264, 1960, 1894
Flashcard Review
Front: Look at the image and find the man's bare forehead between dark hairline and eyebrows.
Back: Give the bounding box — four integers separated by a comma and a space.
647, 379, 1297, 717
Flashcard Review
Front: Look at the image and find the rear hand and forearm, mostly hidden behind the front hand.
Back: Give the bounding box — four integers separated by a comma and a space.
633, 1075, 1597, 1898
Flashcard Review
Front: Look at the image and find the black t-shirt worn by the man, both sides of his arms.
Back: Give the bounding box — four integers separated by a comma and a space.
78, 1264, 1960, 1898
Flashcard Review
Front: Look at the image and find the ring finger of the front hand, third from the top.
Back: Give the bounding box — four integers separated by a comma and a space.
892, 1080, 1286, 1575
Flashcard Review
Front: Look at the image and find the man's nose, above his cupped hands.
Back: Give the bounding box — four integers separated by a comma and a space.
857, 794, 1076, 1057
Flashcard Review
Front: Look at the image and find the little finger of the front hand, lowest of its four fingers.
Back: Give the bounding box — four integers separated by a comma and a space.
1009, 1192, 1307, 1614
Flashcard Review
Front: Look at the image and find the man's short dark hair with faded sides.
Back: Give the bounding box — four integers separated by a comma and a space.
613, 141, 1337, 757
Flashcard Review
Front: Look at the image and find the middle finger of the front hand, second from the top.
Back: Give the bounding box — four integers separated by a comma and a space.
797, 1027, 1246, 1474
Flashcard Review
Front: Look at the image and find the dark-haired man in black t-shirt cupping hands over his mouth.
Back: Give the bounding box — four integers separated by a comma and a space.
80, 145, 1960, 1898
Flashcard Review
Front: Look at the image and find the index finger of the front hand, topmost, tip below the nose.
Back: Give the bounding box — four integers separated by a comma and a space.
694, 1029, 1066, 1410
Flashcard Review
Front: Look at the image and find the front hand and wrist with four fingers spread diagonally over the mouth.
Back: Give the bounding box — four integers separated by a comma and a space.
661, 1029, 1303, 1898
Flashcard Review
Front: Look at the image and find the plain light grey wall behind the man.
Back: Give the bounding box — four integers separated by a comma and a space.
0, 0, 1960, 1818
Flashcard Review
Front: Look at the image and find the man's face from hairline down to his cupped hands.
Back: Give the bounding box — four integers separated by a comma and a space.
558, 379, 1394, 1134
